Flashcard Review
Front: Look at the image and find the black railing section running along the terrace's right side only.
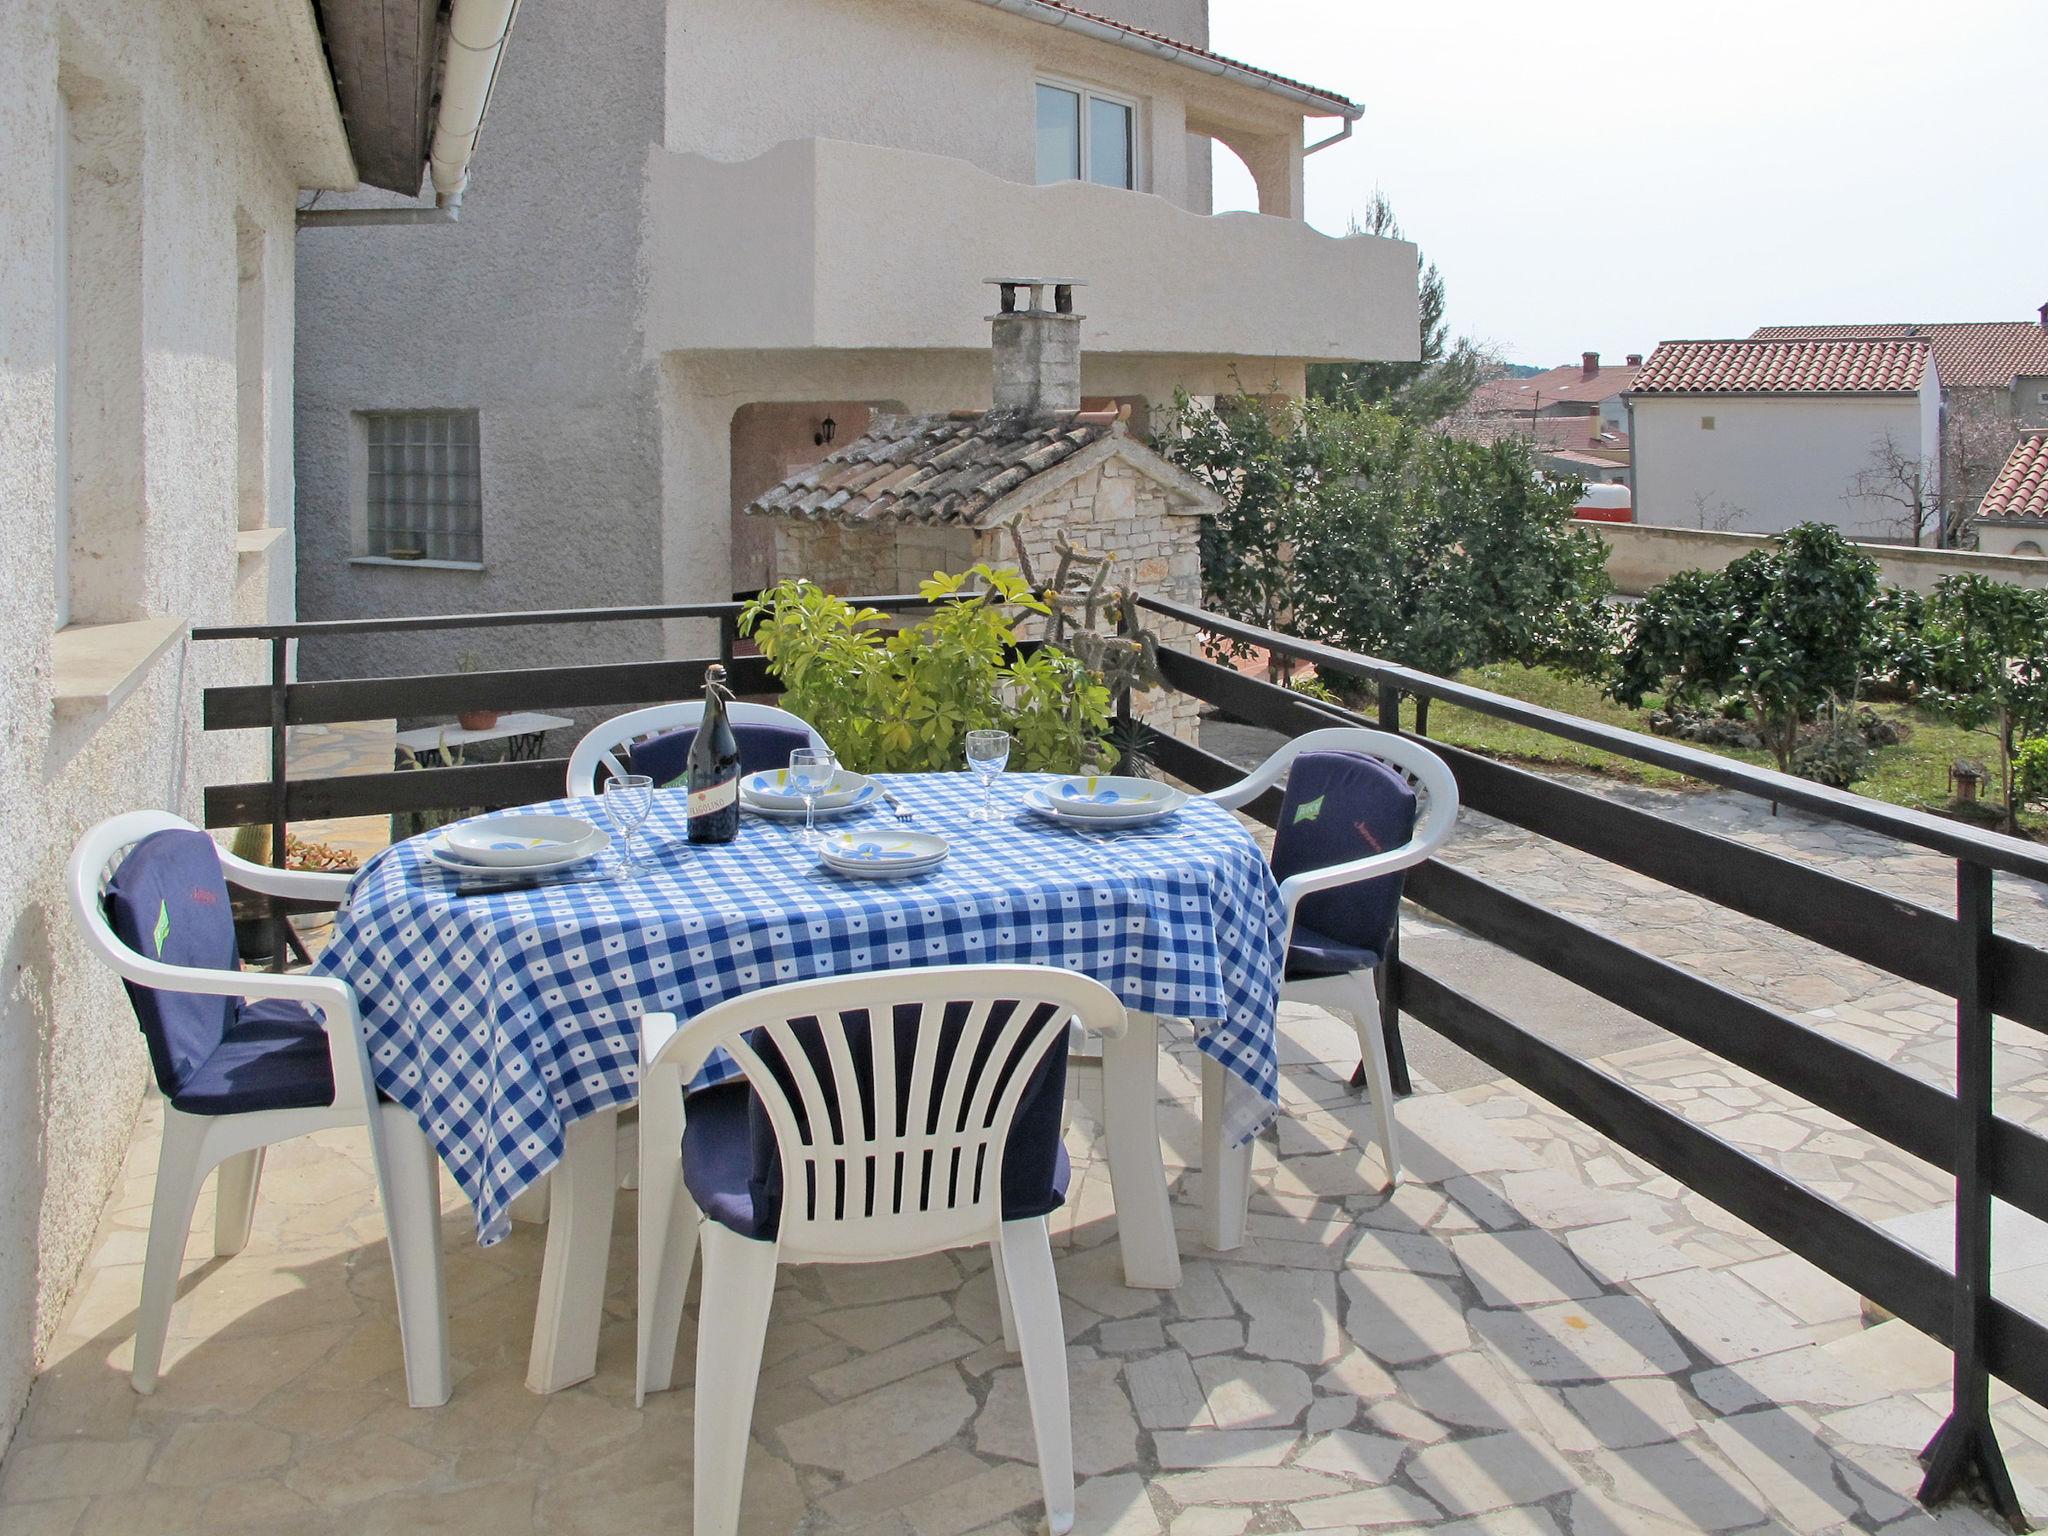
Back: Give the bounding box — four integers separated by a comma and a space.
1143, 600, 2048, 1530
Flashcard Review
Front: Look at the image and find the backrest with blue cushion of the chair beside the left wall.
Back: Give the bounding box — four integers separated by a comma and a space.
72, 811, 240, 1098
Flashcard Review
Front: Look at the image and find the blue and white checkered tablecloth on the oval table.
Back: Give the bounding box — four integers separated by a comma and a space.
315, 774, 1286, 1243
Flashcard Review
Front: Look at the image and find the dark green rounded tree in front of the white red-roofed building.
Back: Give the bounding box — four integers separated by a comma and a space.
1610, 522, 1884, 772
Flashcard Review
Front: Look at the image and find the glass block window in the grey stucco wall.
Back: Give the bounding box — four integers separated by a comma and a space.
362, 412, 483, 563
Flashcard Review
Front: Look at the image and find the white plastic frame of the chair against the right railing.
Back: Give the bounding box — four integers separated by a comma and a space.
1204, 725, 1458, 1208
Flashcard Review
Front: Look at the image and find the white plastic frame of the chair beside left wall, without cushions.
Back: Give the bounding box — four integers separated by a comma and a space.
68, 811, 449, 1407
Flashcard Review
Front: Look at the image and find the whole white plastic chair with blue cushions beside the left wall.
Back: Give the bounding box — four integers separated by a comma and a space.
68, 811, 449, 1407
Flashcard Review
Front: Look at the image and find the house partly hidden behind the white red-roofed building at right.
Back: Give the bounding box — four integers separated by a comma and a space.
1755, 313, 2048, 530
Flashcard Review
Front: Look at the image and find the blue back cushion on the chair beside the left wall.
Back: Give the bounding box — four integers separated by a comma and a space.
104, 827, 242, 1100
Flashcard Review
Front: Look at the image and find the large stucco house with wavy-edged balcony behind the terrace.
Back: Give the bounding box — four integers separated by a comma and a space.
297, 0, 1417, 670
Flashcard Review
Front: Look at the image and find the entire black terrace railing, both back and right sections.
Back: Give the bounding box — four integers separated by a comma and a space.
195, 596, 2048, 1522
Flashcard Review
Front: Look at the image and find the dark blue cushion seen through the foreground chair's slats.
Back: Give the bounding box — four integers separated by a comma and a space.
682, 1004, 1071, 1241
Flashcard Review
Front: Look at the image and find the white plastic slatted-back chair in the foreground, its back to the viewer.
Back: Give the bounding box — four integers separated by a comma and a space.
635, 965, 1126, 1536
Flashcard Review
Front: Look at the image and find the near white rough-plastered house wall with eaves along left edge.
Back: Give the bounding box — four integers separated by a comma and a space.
0, 0, 507, 1458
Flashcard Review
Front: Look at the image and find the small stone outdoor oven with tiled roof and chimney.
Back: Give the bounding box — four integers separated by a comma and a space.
745, 279, 1219, 729
